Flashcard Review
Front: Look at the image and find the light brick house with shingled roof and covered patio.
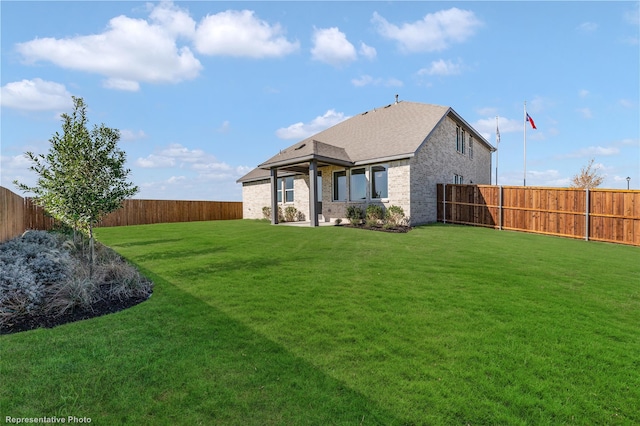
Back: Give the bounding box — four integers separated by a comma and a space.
238, 101, 495, 226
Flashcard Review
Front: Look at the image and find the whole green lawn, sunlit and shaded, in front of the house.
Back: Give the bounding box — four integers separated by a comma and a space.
0, 221, 640, 425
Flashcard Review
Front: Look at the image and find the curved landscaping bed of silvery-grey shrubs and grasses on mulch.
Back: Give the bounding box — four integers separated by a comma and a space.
0, 231, 152, 334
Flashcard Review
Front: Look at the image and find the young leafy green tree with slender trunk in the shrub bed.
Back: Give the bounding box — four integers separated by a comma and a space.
14, 96, 138, 270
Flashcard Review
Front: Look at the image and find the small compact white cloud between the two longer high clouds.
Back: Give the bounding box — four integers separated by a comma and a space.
311, 27, 358, 67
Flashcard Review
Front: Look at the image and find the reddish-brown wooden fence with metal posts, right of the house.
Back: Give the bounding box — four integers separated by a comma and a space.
437, 184, 640, 246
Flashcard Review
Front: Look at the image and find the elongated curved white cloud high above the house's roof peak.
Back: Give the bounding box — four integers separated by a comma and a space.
371, 7, 483, 53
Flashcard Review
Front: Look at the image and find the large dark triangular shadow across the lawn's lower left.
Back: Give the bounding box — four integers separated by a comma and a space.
0, 271, 404, 425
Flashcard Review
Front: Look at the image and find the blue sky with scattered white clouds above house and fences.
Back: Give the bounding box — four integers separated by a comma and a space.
0, 1, 640, 200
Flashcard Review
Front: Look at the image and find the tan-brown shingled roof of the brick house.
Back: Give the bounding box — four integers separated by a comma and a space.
238, 101, 495, 182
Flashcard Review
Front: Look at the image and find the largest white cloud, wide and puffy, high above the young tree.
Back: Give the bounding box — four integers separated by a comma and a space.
16, 3, 202, 91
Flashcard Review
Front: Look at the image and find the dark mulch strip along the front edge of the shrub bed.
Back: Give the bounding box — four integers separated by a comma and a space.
0, 296, 150, 335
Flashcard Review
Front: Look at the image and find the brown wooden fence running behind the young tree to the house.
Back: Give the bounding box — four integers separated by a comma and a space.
0, 186, 242, 242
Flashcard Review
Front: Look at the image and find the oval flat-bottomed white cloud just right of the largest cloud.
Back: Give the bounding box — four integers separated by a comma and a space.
194, 10, 300, 58
